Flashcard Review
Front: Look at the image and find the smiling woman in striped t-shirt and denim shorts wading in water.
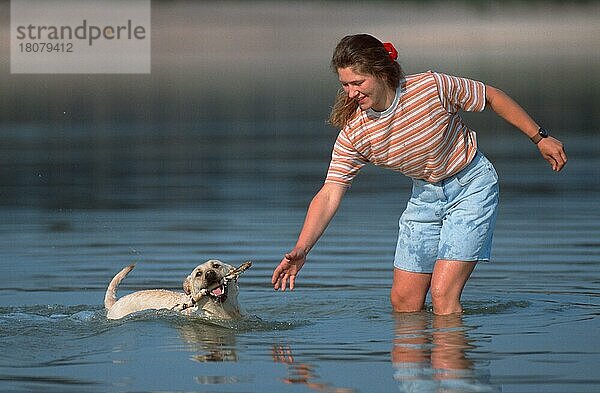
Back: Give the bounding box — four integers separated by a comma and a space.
272, 34, 567, 314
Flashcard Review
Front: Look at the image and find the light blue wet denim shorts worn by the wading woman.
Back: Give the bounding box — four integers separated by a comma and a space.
394, 152, 498, 273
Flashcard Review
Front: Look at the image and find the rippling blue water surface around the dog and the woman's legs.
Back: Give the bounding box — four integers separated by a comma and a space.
0, 123, 600, 392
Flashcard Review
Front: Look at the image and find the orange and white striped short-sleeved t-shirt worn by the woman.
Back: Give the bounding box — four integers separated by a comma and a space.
325, 71, 485, 187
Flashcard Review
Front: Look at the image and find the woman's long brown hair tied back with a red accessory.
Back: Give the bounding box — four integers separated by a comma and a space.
329, 34, 403, 128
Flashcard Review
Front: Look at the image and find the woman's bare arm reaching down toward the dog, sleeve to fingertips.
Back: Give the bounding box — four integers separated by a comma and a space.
271, 183, 346, 291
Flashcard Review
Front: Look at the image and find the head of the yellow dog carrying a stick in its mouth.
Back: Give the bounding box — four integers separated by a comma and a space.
183, 259, 240, 318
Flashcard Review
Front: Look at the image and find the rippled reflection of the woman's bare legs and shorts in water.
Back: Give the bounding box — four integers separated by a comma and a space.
391, 312, 497, 392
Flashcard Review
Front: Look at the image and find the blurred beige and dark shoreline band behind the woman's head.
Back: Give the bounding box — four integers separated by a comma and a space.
0, 1, 600, 125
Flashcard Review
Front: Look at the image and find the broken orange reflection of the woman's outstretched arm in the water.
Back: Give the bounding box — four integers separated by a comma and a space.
271, 344, 356, 393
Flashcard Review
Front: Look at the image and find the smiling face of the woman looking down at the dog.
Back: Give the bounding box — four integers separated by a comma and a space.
337, 67, 396, 112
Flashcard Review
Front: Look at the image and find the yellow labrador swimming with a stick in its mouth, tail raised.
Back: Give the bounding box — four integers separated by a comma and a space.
104, 259, 243, 319
